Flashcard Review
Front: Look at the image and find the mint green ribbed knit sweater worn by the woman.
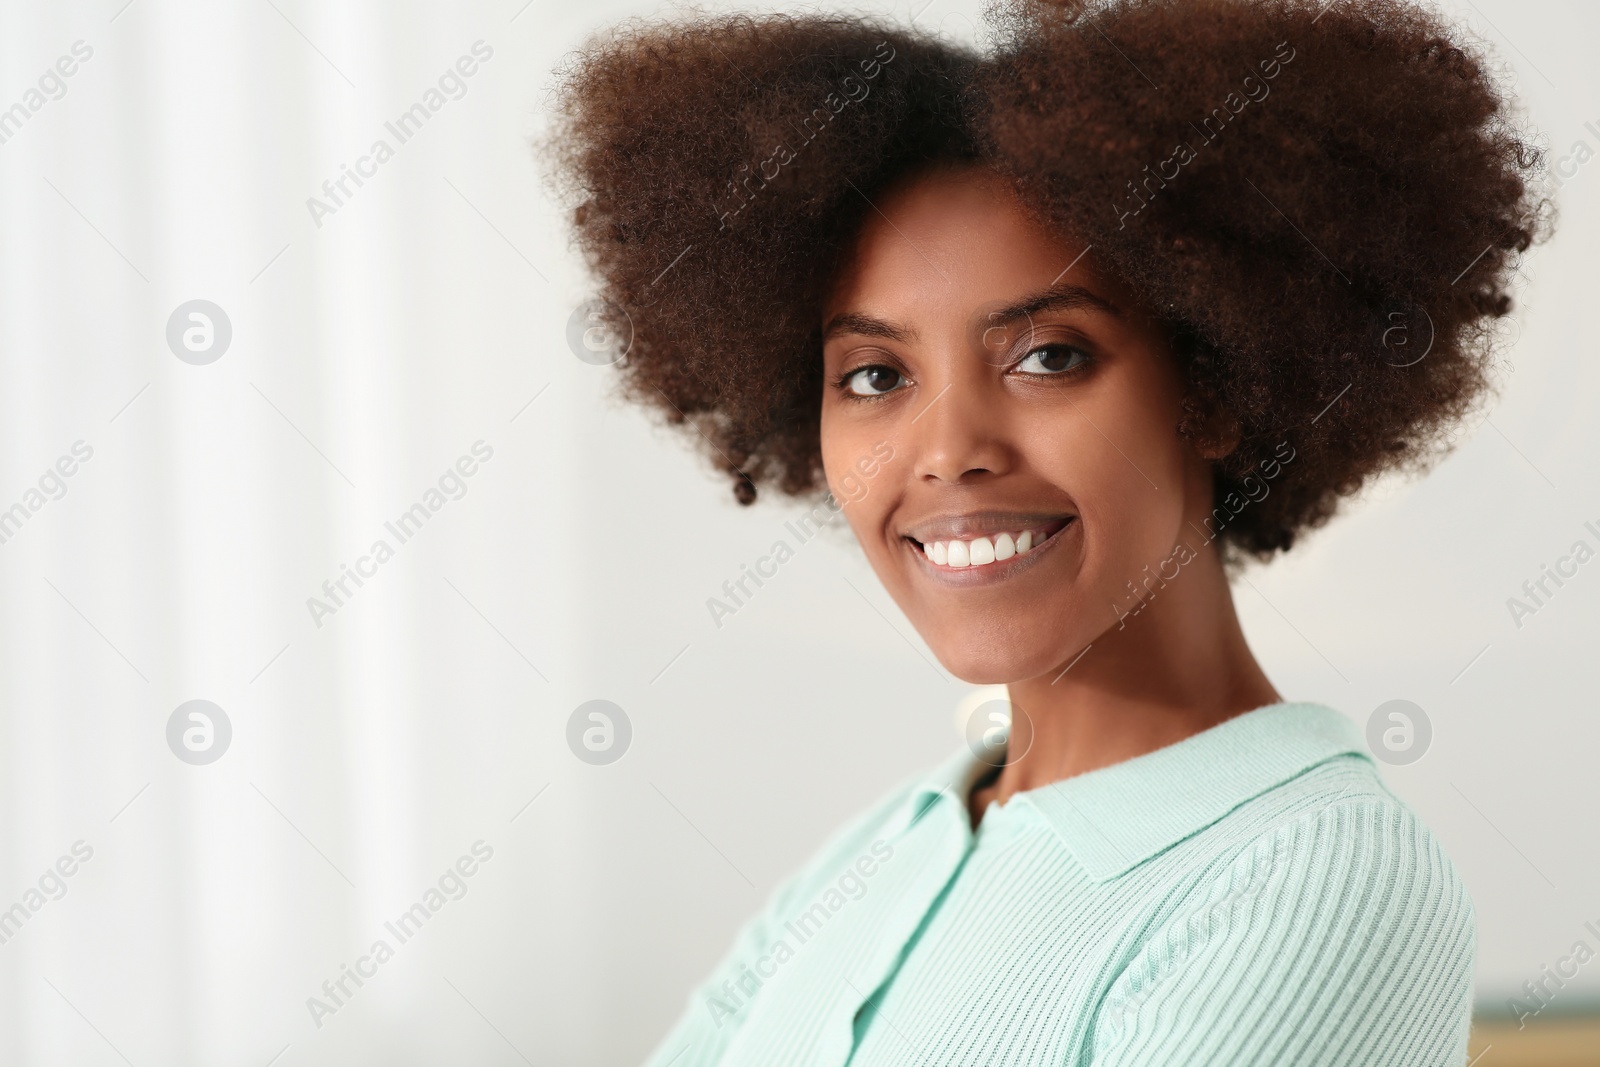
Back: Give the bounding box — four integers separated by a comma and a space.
636, 704, 1475, 1067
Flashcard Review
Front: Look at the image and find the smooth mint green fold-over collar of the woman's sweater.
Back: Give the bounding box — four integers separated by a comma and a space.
907, 702, 1371, 881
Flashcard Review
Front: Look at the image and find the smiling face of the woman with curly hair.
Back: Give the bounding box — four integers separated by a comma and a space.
821, 168, 1211, 683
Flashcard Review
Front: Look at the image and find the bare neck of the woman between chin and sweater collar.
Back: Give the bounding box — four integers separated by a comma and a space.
968, 545, 1282, 827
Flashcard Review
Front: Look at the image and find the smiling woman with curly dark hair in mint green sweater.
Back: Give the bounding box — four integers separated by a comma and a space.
557, 0, 1541, 1067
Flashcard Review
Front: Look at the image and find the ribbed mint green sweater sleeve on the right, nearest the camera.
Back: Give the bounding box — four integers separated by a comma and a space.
1088, 797, 1477, 1067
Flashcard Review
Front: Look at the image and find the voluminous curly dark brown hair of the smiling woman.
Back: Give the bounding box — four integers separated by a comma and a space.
547, 0, 1550, 560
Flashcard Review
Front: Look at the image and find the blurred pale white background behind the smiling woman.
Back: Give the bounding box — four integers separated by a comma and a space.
0, 0, 1600, 1067
